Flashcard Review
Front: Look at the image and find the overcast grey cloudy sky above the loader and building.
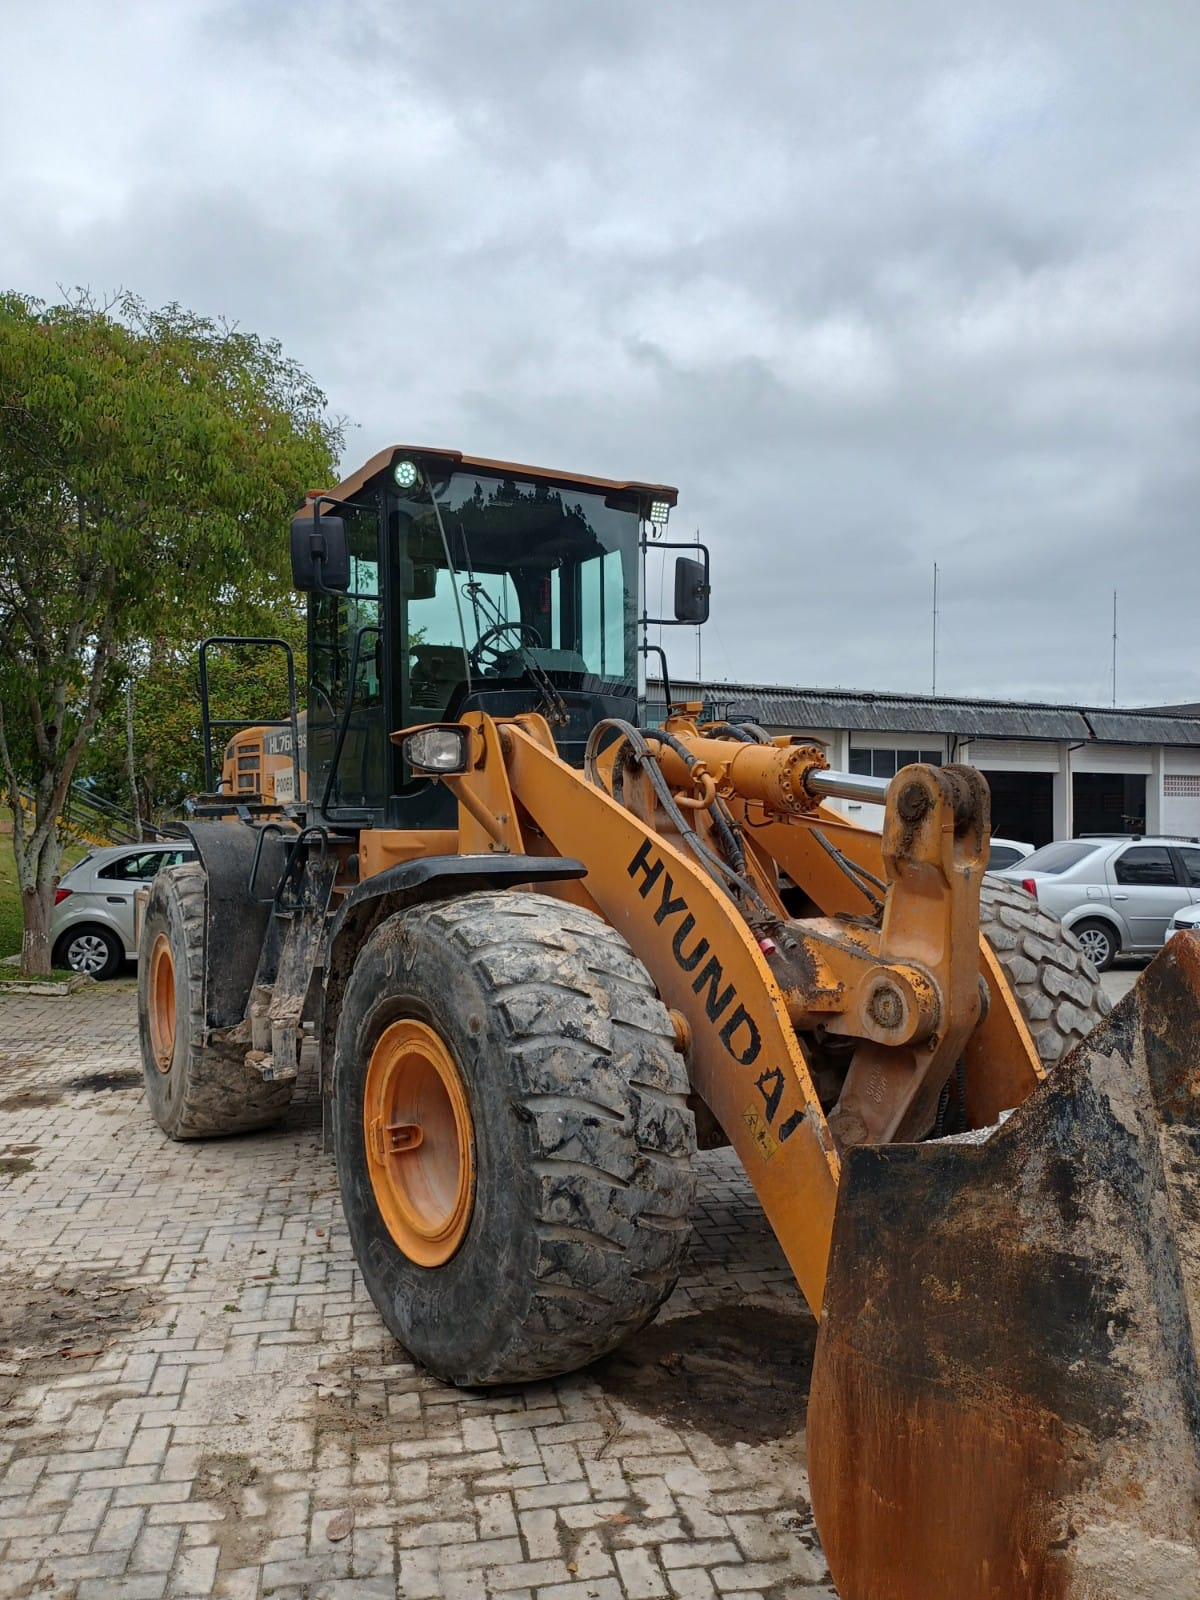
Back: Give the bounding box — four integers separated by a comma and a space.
0, 0, 1200, 704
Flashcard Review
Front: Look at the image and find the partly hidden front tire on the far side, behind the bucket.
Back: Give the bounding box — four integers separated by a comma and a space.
979, 877, 1112, 1067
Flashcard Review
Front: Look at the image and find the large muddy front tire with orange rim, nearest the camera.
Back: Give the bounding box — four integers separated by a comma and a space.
334, 891, 694, 1384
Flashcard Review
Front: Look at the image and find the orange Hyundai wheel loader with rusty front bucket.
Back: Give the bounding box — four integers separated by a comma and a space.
139, 446, 1200, 1600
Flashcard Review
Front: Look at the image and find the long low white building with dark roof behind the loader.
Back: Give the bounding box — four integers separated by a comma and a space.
648, 680, 1200, 845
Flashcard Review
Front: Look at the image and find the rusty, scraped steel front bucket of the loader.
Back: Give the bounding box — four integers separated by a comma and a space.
808, 934, 1200, 1600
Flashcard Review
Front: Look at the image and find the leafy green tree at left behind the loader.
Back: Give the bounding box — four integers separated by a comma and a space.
0, 293, 341, 974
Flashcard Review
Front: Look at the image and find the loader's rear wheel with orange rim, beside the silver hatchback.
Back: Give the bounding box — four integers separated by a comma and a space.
138, 861, 294, 1139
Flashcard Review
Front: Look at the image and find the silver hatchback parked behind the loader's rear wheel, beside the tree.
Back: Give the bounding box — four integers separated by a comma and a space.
50, 840, 195, 978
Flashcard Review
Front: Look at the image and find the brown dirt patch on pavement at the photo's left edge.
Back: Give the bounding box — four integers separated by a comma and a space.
0, 1272, 155, 1437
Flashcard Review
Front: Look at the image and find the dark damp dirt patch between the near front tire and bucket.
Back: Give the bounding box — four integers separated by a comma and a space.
587, 1306, 816, 1445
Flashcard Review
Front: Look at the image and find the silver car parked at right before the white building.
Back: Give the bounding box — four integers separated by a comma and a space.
997, 834, 1200, 971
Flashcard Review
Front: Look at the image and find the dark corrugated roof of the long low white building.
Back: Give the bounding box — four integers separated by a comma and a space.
648, 678, 1200, 746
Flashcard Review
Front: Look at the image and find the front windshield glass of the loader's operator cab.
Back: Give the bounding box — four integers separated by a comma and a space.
395, 472, 638, 720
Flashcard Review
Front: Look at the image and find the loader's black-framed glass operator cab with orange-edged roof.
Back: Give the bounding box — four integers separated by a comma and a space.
291, 446, 707, 827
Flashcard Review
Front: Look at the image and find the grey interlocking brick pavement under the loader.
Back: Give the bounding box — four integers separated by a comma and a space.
0, 979, 834, 1600
